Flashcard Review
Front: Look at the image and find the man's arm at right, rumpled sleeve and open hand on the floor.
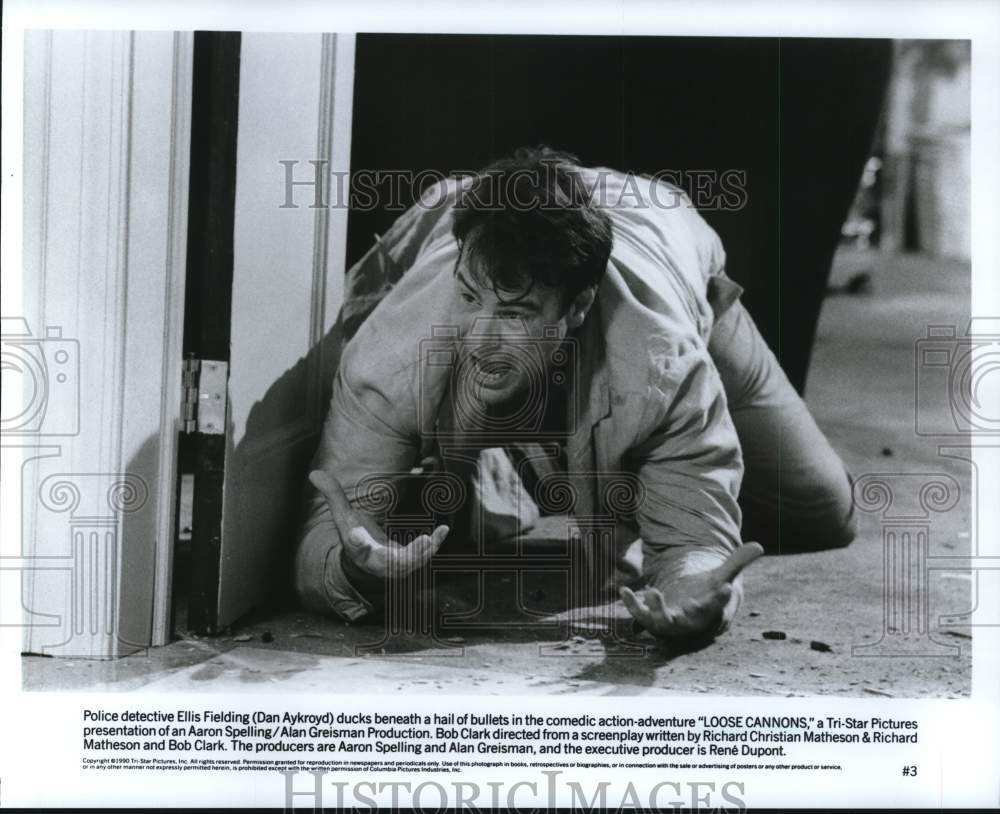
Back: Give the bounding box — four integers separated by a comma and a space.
622, 342, 761, 638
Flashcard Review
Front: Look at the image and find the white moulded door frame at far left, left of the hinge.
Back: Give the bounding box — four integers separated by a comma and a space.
14, 31, 193, 658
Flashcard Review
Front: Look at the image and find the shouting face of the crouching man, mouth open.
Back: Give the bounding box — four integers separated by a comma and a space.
455, 259, 575, 405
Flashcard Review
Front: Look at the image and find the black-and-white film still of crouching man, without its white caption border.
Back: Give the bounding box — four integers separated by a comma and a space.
4, 32, 976, 697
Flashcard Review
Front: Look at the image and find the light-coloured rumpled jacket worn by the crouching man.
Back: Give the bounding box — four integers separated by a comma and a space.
296, 169, 743, 619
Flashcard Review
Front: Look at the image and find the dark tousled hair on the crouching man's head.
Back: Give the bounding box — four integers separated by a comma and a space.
452, 146, 612, 305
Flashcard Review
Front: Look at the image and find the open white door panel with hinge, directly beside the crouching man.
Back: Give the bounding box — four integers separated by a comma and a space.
213, 32, 355, 629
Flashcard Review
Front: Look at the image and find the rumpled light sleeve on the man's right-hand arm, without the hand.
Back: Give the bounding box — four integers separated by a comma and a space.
629, 340, 743, 627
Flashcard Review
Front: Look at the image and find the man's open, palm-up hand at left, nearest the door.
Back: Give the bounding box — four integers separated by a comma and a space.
309, 470, 448, 580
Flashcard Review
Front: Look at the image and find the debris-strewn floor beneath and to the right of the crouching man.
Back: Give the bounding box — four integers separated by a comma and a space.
23, 245, 973, 697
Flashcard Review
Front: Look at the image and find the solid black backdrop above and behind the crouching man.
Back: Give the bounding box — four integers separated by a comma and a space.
348, 34, 892, 391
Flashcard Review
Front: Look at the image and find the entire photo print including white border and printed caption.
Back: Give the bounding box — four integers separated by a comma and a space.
0, 3, 1000, 810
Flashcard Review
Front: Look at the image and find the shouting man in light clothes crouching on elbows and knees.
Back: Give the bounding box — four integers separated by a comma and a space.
295, 148, 854, 641
